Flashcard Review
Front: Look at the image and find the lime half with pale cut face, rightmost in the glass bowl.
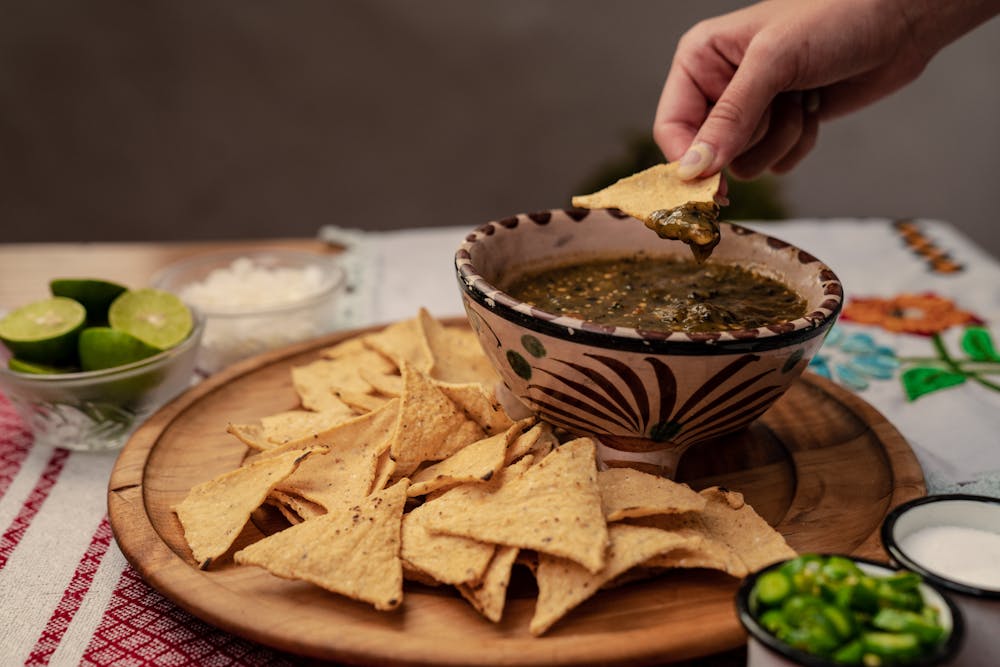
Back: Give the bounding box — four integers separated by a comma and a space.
108, 288, 193, 350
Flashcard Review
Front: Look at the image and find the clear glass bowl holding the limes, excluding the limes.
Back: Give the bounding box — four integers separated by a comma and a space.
0, 313, 205, 451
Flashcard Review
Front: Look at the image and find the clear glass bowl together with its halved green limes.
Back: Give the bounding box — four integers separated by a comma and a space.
0, 278, 205, 451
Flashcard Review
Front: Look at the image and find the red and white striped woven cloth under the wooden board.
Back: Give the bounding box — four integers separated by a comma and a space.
0, 394, 303, 667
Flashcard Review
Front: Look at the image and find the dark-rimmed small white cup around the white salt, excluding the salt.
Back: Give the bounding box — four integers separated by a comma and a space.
882, 494, 1000, 666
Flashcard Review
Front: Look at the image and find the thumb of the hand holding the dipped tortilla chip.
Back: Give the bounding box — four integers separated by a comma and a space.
677, 43, 789, 179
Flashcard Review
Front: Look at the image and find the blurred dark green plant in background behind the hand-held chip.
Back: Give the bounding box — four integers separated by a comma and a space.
574, 132, 788, 220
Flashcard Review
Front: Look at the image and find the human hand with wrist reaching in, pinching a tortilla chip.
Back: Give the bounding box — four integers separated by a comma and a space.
653, 0, 1000, 178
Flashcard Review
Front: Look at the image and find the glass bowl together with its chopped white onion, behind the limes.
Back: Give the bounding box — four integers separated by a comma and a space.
152, 249, 346, 374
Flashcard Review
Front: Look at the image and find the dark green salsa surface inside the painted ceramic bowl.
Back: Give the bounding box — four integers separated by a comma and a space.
504, 253, 806, 332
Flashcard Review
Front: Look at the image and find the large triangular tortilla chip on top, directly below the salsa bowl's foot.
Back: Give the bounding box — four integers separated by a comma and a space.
425, 438, 608, 572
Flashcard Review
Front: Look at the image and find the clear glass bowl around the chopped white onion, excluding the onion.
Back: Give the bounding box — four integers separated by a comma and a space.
152, 250, 345, 374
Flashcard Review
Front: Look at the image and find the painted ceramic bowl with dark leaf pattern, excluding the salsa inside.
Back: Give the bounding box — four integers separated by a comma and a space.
455, 208, 843, 474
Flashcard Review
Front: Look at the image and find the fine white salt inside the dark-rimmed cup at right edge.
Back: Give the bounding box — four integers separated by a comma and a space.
899, 526, 1000, 589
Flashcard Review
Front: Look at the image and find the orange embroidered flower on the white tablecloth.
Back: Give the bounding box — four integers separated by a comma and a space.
841, 292, 983, 336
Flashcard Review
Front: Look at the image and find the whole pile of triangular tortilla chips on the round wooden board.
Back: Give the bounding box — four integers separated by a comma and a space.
175, 310, 794, 635
